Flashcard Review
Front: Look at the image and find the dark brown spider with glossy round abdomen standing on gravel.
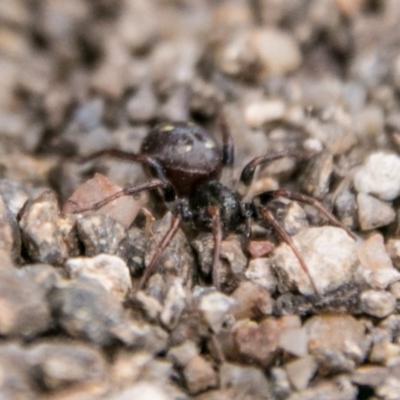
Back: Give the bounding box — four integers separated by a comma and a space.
68, 116, 354, 293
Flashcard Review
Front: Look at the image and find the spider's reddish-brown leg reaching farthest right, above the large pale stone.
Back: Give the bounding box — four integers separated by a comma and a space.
256, 189, 357, 240
